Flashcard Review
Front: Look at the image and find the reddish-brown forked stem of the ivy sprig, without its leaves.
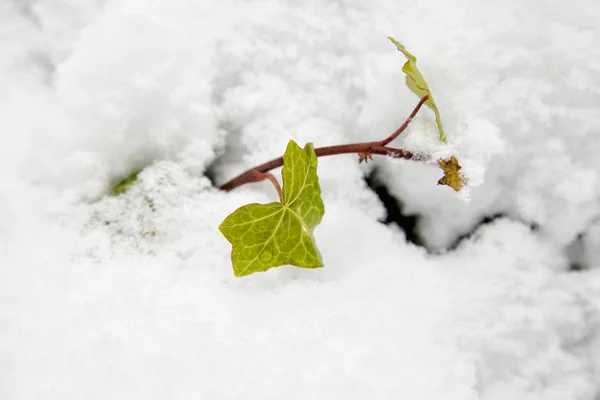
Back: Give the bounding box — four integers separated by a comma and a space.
219, 96, 428, 191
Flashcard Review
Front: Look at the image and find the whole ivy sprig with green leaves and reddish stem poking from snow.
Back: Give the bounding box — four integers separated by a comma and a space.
219, 37, 466, 276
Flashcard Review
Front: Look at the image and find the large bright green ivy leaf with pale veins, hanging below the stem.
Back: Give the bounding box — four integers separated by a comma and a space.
219, 140, 325, 276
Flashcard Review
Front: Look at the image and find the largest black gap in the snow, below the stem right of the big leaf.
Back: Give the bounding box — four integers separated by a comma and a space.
365, 169, 425, 247
